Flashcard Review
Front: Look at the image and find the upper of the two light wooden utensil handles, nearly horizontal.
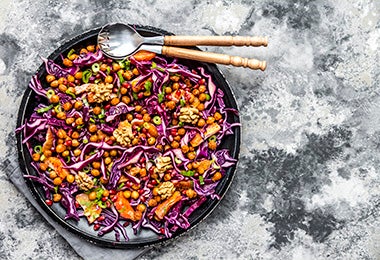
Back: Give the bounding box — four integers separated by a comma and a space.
164, 35, 268, 46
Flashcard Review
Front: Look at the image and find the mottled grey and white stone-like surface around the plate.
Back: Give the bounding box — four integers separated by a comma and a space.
0, 0, 380, 259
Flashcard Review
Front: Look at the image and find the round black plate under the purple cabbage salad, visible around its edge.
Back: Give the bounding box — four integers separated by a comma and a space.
17, 26, 241, 248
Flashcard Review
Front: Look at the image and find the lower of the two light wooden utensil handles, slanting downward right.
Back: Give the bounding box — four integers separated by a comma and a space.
162, 46, 267, 71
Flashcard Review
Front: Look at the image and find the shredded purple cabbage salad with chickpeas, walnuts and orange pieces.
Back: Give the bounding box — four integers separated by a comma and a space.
17, 45, 239, 241
